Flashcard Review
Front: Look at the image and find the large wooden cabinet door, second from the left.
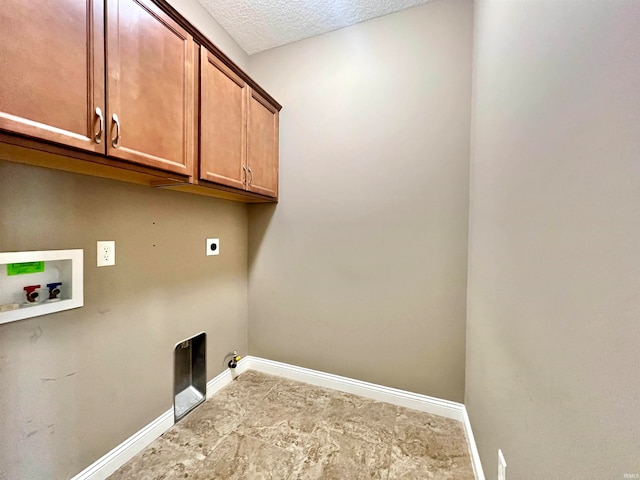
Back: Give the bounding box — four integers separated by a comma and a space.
107, 0, 195, 175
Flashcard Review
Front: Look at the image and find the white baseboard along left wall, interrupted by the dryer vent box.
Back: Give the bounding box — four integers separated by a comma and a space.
71, 358, 249, 480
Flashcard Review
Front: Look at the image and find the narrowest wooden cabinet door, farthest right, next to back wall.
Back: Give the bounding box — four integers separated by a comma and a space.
247, 89, 278, 198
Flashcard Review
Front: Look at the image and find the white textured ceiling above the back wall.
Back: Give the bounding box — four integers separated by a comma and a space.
198, 0, 436, 55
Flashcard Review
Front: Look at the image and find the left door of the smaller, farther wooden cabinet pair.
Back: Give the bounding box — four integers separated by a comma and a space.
200, 48, 247, 190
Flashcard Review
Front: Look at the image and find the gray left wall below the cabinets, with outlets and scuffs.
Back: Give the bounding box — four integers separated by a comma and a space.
0, 161, 248, 480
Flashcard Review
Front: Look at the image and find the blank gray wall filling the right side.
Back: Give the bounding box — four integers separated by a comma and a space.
465, 0, 640, 480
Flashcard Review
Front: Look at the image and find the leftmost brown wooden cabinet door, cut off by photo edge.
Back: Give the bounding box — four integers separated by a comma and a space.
0, 0, 105, 153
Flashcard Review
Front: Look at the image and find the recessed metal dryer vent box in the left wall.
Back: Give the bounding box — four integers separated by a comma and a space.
173, 332, 207, 422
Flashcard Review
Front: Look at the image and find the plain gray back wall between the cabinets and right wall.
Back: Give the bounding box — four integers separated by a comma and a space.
249, 0, 473, 401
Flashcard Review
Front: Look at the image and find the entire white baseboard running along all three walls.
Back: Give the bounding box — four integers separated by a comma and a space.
71, 356, 485, 480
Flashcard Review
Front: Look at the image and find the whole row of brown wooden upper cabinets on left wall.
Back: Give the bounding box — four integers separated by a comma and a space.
0, 0, 280, 202
